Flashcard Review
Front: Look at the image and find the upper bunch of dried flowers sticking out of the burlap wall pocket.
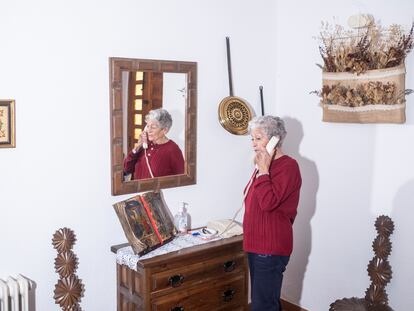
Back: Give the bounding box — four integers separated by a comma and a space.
318, 20, 414, 75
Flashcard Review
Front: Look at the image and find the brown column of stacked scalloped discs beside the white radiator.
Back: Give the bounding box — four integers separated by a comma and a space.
52, 228, 84, 311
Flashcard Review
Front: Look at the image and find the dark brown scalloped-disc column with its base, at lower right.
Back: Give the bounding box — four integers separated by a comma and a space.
329, 215, 394, 311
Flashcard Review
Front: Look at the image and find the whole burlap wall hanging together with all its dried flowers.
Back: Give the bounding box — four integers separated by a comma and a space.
312, 15, 414, 123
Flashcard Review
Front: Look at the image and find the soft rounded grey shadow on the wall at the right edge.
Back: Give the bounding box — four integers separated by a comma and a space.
386, 179, 414, 310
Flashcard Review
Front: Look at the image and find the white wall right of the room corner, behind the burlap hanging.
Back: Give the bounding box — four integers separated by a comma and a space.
272, 0, 414, 311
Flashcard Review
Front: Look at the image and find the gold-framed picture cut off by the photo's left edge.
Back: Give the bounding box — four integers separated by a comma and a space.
0, 99, 16, 148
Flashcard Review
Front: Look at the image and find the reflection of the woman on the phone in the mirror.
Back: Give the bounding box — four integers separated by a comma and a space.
124, 109, 184, 179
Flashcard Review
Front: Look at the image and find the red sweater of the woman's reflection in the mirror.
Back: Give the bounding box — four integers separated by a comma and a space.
124, 139, 184, 179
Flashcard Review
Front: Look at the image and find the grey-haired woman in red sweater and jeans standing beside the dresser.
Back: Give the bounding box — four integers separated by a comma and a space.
243, 116, 302, 311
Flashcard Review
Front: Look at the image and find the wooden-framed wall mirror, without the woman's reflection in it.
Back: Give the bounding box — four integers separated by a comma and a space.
109, 57, 197, 195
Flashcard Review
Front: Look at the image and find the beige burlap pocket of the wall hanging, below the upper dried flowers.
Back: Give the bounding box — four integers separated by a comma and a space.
322, 65, 405, 123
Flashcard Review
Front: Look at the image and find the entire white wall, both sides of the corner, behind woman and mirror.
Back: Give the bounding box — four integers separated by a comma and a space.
0, 0, 414, 311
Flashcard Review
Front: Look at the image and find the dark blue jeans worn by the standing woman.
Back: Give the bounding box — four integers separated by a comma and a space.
247, 253, 289, 311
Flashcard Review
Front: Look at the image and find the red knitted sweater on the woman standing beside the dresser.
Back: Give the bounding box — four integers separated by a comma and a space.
243, 155, 302, 256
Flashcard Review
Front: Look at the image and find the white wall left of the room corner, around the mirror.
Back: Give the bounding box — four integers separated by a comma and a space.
0, 0, 275, 311
